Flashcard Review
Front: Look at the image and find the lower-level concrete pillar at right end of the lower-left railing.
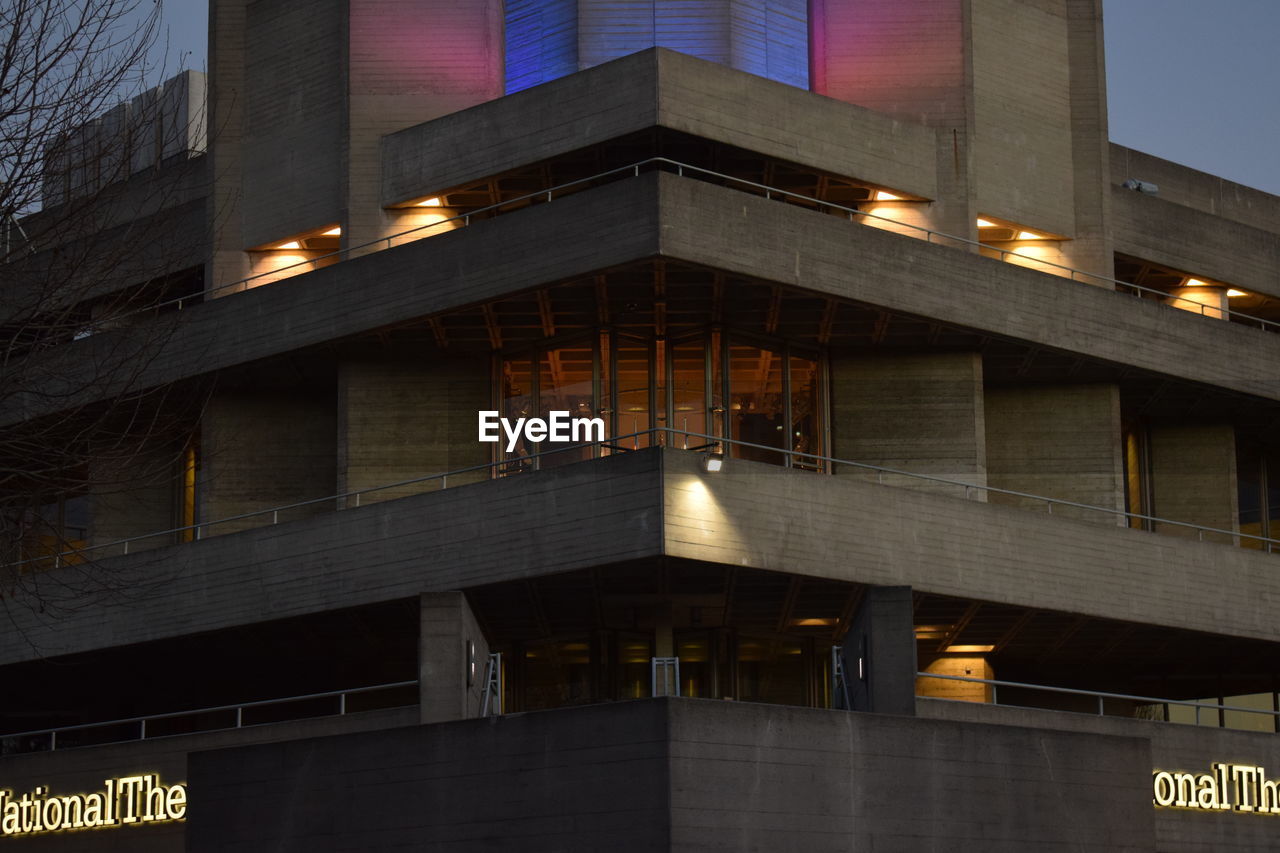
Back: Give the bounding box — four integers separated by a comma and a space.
417, 592, 489, 722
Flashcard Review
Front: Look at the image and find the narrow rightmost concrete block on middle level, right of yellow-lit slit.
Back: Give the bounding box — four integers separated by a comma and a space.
1151, 424, 1239, 542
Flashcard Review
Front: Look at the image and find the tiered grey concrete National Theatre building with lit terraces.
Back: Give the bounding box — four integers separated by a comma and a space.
0, 0, 1280, 853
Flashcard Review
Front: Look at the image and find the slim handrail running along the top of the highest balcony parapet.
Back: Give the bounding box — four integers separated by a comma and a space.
87, 156, 1280, 332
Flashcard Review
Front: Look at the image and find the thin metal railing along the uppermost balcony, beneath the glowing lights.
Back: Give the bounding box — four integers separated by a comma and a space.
82, 158, 1280, 332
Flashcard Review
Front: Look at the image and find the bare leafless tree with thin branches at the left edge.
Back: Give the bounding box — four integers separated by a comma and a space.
0, 0, 206, 610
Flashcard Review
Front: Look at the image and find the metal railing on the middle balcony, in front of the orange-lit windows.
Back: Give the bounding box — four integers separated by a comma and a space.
3, 427, 1280, 569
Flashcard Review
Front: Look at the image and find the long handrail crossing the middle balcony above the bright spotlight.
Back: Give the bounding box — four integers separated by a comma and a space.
12, 427, 1280, 569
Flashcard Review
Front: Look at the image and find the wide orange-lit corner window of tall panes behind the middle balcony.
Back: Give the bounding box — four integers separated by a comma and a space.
497, 330, 824, 474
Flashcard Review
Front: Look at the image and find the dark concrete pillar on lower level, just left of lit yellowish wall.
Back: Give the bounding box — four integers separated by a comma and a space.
836, 587, 915, 716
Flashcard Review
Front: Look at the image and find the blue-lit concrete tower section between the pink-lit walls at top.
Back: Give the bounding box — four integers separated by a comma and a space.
506, 0, 809, 95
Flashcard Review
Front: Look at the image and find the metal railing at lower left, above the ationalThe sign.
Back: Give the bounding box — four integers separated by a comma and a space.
0, 680, 417, 754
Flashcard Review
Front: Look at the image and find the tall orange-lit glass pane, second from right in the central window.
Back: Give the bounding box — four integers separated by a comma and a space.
728, 341, 787, 465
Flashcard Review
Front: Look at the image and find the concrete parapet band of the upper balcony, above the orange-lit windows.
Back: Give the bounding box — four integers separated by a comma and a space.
12, 174, 1280, 424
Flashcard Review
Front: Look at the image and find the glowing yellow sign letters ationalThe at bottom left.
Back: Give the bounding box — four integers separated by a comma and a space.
0, 774, 187, 835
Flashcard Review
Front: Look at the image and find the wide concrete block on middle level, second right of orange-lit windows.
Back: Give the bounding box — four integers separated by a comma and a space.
986, 384, 1125, 526
